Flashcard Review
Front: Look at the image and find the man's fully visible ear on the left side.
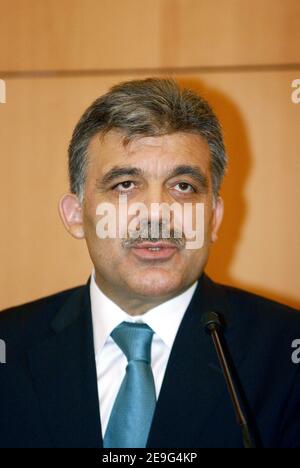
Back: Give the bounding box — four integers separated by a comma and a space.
58, 193, 85, 239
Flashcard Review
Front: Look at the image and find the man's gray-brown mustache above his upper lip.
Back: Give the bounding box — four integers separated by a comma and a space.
122, 221, 186, 250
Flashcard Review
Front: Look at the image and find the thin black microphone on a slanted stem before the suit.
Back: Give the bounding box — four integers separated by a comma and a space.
202, 312, 255, 448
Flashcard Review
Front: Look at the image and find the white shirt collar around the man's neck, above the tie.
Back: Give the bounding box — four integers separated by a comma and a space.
90, 271, 197, 355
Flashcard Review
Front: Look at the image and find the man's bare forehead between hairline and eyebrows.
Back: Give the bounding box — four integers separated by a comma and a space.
88, 130, 210, 175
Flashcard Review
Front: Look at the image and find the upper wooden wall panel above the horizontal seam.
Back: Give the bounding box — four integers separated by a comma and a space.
0, 0, 300, 75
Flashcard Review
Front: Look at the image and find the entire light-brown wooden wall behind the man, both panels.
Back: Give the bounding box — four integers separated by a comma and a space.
0, 0, 300, 309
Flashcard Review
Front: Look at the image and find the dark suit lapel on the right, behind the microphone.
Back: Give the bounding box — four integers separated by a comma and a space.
147, 274, 242, 448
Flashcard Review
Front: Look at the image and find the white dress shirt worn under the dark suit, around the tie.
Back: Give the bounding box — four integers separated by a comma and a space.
90, 272, 197, 437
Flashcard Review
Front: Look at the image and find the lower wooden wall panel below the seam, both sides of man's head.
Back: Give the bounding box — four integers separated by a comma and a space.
0, 72, 300, 309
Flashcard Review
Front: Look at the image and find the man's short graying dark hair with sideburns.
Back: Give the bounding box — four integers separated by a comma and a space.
69, 78, 227, 200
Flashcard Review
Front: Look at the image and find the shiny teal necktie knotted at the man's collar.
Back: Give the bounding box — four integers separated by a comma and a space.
103, 322, 156, 448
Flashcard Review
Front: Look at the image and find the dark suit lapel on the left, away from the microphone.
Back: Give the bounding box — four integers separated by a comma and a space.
29, 285, 102, 447
